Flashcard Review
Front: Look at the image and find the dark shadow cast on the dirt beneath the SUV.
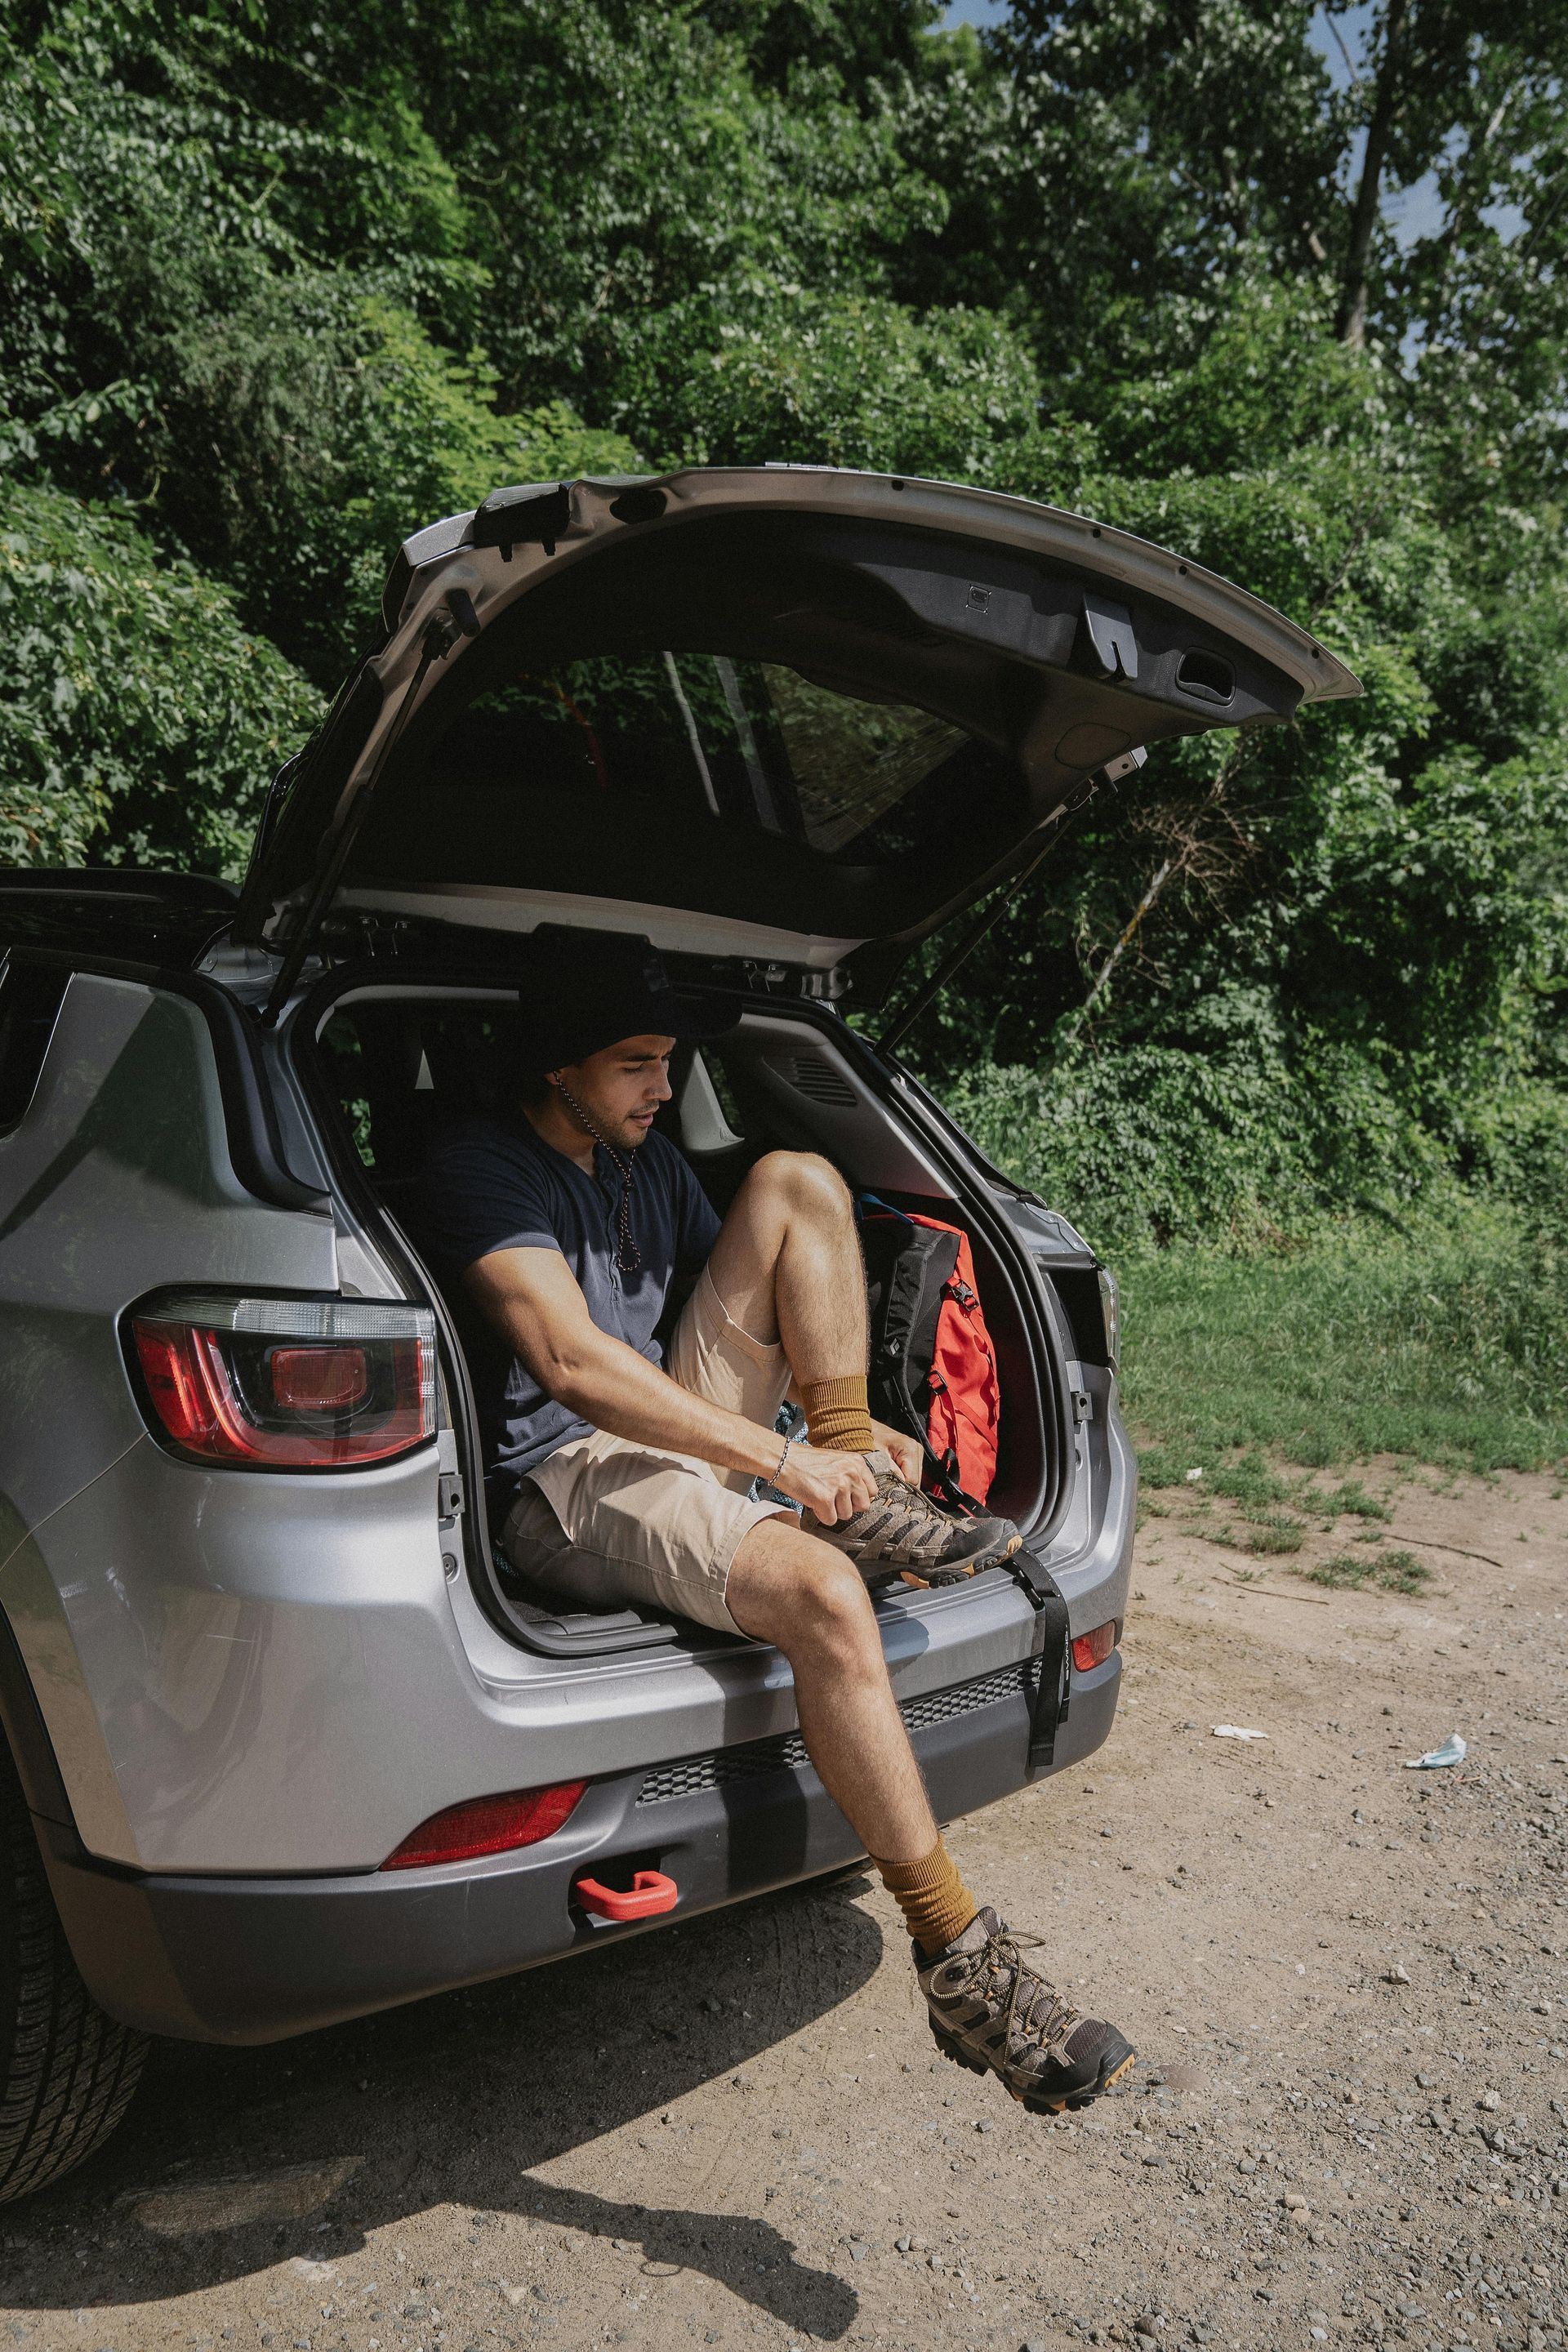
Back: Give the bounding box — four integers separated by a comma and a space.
7, 1882, 881, 2338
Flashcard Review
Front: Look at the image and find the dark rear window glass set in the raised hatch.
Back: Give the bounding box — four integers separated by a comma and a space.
430, 652, 1011, 866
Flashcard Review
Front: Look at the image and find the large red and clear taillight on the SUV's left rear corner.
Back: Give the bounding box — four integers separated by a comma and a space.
131, 1291, 435, 1470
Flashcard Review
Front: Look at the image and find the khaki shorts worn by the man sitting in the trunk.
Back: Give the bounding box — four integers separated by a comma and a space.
501, 1267, 790, 1633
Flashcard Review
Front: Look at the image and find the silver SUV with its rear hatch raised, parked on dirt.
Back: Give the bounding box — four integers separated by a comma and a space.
0, 468, 1356, 2197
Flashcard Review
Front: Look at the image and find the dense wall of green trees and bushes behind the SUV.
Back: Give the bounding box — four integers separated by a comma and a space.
0, 0, 1568, 1235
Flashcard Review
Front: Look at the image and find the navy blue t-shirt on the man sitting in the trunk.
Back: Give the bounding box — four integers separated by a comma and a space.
418, 1115, 719, 1524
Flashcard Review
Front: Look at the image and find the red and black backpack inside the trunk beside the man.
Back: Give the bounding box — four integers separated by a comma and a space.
858, 1195, 1001, 1503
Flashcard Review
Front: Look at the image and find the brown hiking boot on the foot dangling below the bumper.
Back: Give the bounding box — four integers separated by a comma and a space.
915, 1908, 1135, 2114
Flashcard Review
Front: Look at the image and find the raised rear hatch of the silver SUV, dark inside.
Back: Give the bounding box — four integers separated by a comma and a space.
238, 468, 1359, 992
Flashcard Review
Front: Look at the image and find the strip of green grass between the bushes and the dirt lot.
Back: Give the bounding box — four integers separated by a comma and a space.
1116, 1200, 1568, 1458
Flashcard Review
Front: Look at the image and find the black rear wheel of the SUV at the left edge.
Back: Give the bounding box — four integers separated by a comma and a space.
0, 1735, 145, 2204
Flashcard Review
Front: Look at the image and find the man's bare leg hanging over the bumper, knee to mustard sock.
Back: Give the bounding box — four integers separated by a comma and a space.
724, 1514, 936, 1863
